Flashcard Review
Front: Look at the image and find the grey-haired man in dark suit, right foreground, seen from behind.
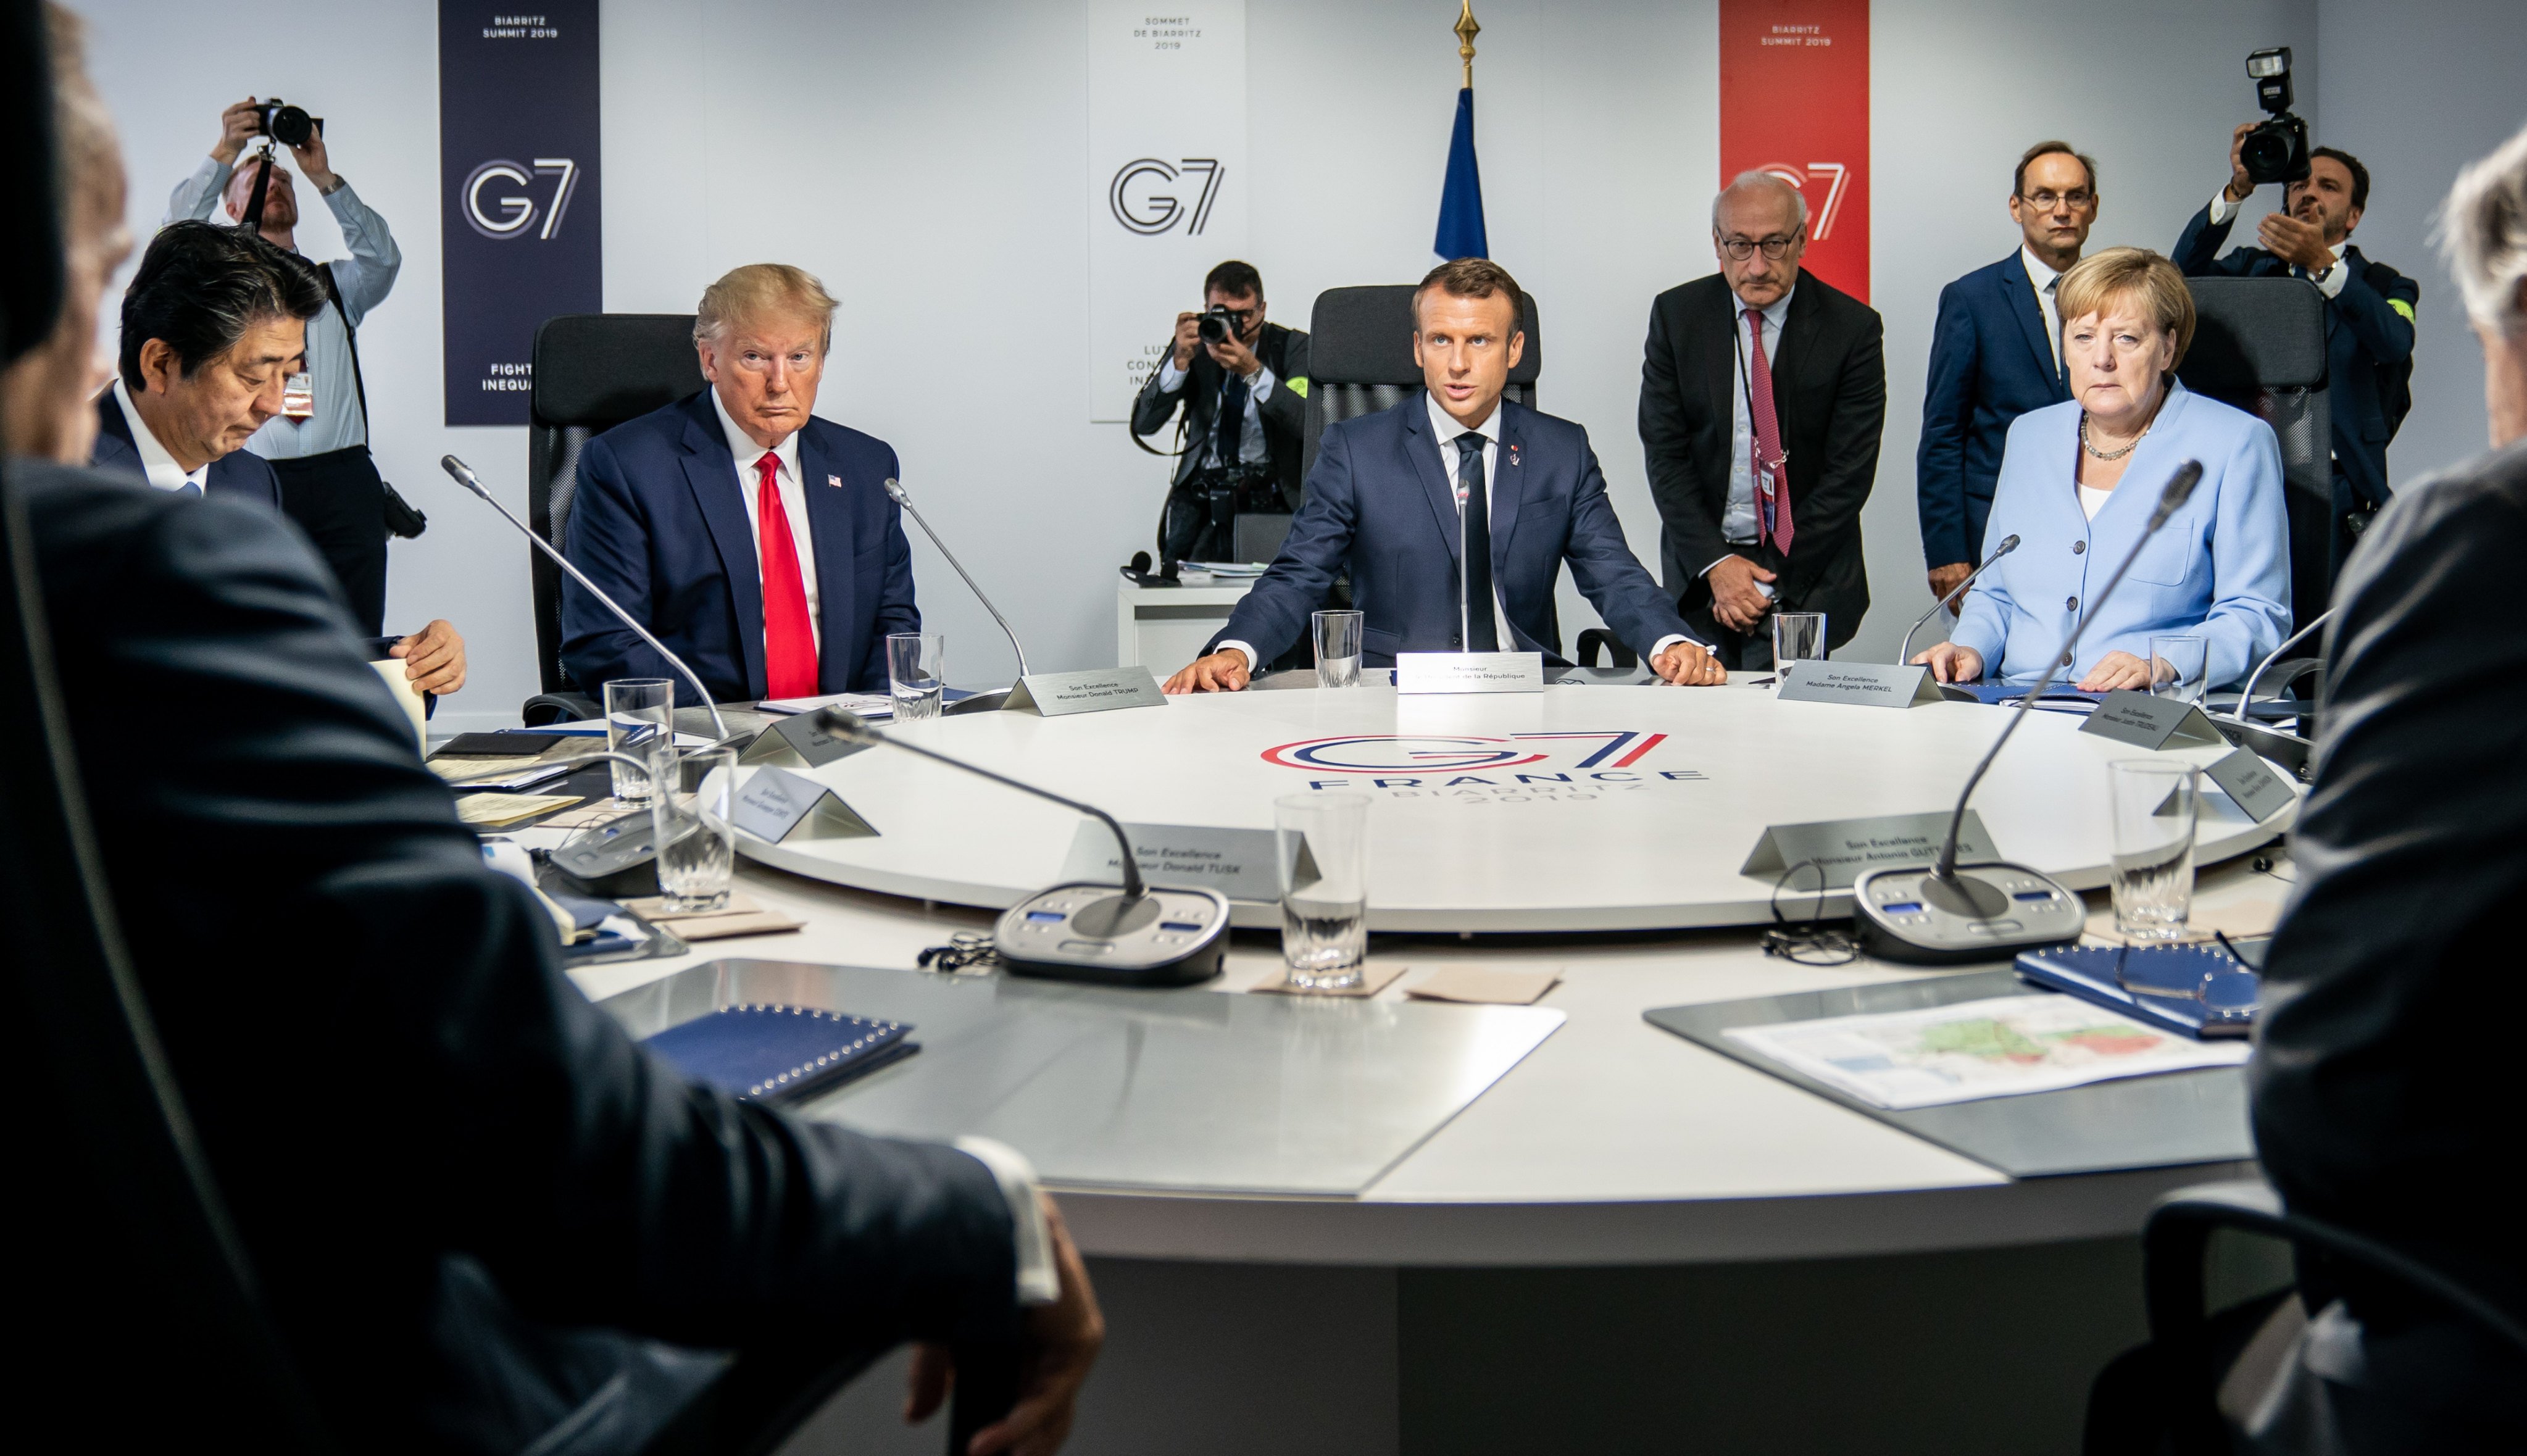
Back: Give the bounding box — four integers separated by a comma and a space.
2088, 129, 2527, 1456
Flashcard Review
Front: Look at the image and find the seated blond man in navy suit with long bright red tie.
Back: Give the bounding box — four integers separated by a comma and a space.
561, 263, 922, 703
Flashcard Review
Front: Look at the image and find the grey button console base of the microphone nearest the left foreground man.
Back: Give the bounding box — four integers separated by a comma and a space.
991, 884, 1228, 986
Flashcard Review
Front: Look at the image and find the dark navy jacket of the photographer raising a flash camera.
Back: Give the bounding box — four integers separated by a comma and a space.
2173, 202, 2421, 510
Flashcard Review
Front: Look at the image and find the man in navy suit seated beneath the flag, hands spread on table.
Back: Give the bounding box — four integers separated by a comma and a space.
1167, 258, 1726, 693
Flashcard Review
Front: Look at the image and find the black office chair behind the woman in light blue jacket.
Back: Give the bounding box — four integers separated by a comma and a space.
2176, 278, 2335, 630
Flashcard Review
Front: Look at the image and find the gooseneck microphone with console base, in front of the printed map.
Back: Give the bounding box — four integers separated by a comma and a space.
1852, 460, 2204, 965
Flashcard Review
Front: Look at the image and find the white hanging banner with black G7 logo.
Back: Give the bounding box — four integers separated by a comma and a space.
1086, 0, 1251, 422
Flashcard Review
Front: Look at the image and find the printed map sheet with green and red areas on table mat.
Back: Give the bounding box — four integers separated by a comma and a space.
1726, 991, 2247, 1110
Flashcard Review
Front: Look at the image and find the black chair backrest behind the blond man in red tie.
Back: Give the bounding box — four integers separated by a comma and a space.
526, 314, 702, 693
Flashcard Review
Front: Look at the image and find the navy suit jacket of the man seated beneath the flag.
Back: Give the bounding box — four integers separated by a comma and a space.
1203, 392, 1693, 667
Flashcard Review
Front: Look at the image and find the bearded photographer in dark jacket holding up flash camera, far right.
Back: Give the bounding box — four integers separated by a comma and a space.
2168, 122, 2421, 599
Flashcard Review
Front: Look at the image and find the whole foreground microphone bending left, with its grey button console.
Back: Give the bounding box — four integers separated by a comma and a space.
816, 708, 1228, 986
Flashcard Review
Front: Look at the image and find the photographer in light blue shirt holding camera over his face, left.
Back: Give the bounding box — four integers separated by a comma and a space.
167, 96, 422, 637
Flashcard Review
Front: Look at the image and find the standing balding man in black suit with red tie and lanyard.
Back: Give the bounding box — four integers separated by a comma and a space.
1640, 172, 1888, 667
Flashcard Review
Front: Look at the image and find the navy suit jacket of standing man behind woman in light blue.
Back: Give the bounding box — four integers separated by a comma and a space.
1913, 248, 2070, 566
